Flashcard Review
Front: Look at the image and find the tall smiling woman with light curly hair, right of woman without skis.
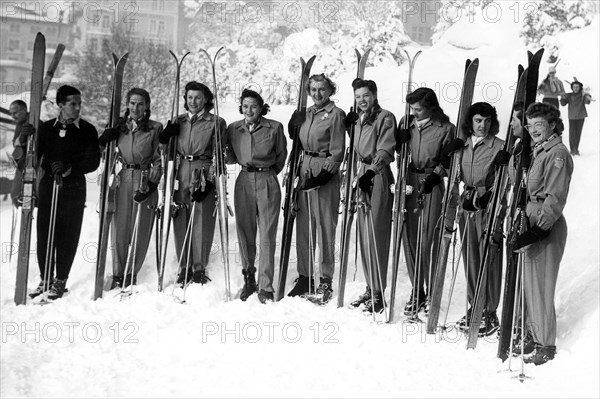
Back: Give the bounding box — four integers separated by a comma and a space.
288, 74, 346, 303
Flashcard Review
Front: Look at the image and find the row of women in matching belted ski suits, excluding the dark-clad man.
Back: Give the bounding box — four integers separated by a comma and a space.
95, 70, 573, 364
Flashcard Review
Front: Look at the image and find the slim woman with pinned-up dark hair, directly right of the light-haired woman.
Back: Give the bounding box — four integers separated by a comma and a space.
352, 79, 396, 313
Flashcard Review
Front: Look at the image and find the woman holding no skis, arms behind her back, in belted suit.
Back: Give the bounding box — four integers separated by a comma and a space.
227, 89, 287, 303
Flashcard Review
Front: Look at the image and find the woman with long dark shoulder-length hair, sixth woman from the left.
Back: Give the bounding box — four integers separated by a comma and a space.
397, 87, 456, 315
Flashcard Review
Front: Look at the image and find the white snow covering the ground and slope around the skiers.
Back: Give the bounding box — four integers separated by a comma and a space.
0, 3, 600, 397
